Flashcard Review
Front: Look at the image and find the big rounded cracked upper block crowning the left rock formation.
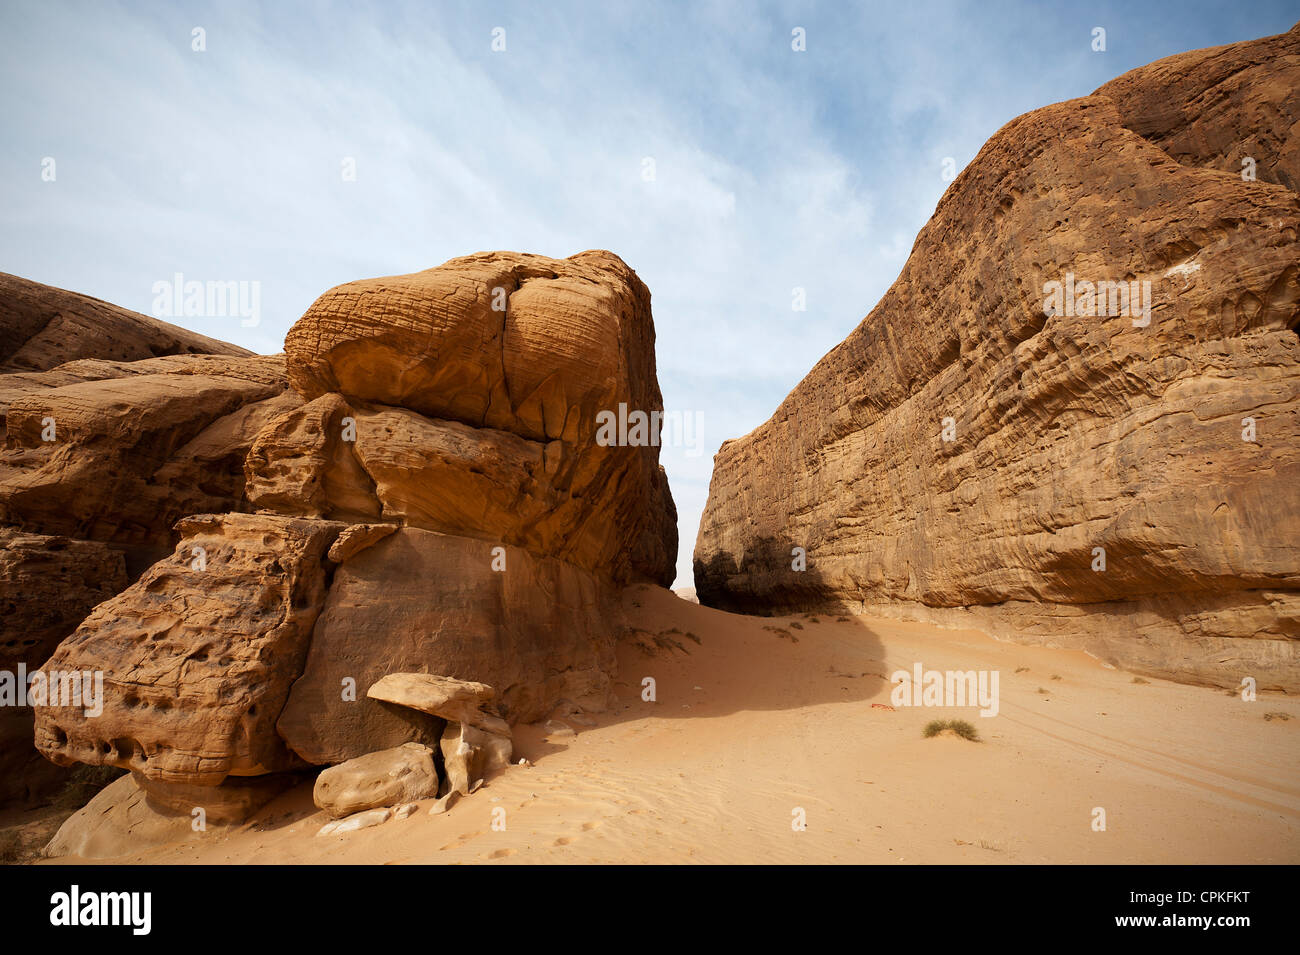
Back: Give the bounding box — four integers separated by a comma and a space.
279, 252, 677, 586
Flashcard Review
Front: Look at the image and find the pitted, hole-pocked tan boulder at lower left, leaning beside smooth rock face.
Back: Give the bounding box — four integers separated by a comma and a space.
35, 515, 343, 786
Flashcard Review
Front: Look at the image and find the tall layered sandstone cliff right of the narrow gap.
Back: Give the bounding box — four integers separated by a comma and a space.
696, 27, 1300, 689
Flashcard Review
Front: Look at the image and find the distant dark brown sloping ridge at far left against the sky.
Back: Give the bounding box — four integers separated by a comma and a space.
0, 272, 252, 374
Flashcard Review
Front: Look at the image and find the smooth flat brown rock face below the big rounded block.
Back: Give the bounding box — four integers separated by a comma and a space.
278, 528, 618, 764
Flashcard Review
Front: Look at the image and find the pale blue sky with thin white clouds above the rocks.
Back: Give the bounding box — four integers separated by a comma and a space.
0, 0, 1300, 587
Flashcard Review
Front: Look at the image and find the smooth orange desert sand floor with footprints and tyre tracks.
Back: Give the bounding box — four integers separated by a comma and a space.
35, 586, 1300, 864
